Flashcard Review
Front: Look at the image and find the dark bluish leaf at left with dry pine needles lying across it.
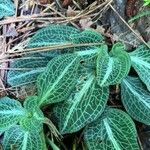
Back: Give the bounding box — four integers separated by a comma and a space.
7, 54, 50, 86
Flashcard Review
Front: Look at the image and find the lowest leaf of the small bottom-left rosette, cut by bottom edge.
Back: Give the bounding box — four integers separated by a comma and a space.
2, 126, 45, 150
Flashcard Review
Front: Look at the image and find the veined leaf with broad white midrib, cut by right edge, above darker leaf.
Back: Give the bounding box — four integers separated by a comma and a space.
130, 46, 150, 91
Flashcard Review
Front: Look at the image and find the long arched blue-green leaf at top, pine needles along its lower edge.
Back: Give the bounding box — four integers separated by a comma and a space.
28, 25, 80, 47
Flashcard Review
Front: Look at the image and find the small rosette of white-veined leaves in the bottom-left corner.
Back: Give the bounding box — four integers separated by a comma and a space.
0, 97, 45, 150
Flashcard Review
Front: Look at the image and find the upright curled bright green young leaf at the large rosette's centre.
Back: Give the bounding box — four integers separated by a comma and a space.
97, 43, 131, 86
